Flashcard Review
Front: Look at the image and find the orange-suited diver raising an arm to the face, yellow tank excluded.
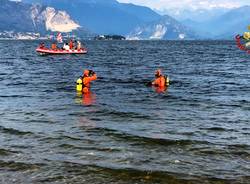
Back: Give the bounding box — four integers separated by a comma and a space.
82, 70, 97, 93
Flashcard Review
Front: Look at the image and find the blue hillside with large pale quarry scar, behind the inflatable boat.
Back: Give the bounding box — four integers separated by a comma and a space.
0, 0, 92, 35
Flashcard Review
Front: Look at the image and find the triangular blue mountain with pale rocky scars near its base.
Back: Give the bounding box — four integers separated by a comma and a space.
127, 15, 196, 40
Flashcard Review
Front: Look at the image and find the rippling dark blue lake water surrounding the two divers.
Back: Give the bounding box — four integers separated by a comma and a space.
0, 41, 250, 184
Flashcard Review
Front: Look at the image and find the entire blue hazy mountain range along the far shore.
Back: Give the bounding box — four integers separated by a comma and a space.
0, 0, 250, 39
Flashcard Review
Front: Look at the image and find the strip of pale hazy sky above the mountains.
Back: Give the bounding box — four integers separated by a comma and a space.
118, 0, 250, 10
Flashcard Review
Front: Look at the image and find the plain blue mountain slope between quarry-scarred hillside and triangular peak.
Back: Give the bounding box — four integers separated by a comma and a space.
24, 0, 160, 35
